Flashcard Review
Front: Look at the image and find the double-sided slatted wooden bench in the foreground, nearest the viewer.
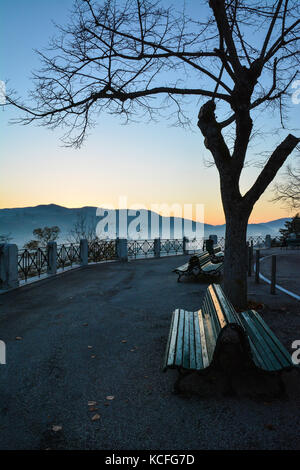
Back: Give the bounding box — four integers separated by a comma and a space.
163, 284, 296, 393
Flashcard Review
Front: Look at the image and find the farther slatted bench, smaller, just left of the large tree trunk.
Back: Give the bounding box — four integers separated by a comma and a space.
173, 251, 223, 282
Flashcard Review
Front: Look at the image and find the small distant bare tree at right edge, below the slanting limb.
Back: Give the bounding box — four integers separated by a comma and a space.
272, 165, 300, 210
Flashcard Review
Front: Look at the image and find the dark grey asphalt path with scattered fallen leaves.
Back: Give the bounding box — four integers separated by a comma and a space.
0, 256, 300, 449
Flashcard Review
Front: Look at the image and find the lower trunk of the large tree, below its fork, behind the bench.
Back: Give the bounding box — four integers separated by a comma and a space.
223, 211, 249, 309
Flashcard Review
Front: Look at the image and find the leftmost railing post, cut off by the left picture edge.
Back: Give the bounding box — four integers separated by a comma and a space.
0, 243, 19, 289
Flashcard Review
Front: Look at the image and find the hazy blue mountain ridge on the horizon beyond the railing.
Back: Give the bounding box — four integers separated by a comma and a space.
0, 204, 291, 248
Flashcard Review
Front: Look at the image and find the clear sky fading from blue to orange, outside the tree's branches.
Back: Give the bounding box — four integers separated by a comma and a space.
0, 0, 300, 224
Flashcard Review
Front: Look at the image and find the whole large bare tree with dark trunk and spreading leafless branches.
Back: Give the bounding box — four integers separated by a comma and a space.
8, 0, 300, 307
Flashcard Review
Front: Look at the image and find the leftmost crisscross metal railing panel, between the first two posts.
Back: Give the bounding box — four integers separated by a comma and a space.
18, 248, 48, 281
